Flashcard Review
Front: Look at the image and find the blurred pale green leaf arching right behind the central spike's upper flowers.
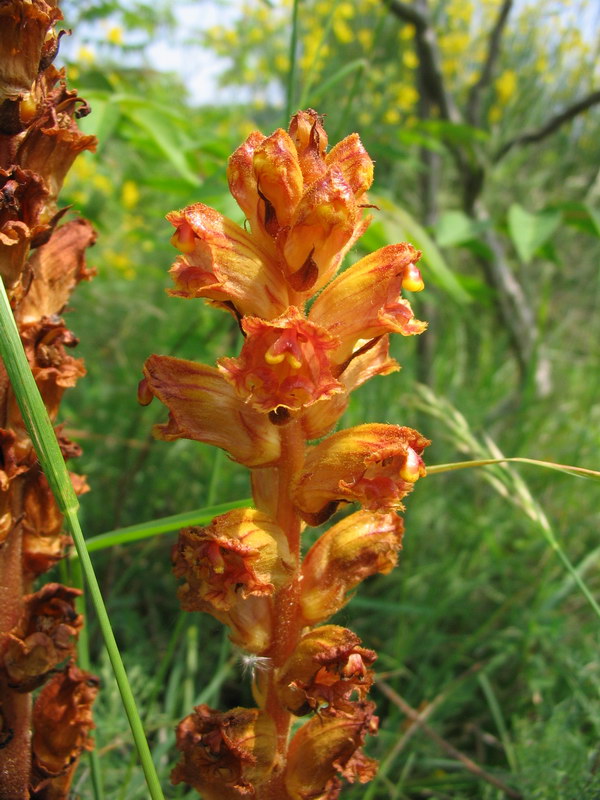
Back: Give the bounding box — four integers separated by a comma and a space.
370, 195, 471, 305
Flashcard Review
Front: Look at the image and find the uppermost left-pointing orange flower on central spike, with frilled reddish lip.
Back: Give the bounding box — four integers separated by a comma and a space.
167, 203, 289, 319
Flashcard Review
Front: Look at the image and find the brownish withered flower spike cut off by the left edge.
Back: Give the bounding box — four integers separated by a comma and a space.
0, 0, 97, 800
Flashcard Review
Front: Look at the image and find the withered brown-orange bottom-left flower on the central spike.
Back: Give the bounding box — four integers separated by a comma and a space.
171, 705, 277, 800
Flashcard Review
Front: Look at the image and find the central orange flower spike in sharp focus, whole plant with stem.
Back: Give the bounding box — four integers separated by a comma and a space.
140, 110, 429, 800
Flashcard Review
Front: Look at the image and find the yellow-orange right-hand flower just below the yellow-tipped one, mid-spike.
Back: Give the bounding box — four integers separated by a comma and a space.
300, 511, 404, 630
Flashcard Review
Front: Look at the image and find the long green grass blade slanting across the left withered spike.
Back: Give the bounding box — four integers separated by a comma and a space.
0, 281, 164, 800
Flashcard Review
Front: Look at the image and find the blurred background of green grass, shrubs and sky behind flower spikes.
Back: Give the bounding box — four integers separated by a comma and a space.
50, 0, 600, 800
